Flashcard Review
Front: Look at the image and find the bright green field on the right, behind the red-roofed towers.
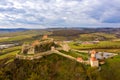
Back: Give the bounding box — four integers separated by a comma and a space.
69, 41, 120, 53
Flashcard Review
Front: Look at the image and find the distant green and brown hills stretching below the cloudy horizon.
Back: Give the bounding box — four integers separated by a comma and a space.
0, 28, 120, 42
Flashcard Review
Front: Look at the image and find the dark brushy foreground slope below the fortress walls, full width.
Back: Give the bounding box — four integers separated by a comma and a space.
0, 54, 120, 80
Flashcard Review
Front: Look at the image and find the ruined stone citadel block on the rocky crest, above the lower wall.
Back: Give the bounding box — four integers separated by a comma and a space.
21, 35, 54, 54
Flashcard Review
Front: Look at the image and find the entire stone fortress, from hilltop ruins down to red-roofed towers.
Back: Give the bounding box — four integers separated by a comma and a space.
16, 35, 114, 67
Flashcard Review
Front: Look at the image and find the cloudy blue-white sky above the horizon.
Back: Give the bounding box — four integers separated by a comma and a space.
0, 0, 120, 28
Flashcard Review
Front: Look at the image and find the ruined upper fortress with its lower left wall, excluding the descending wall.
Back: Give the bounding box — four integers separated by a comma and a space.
16, 35, 70, 60
